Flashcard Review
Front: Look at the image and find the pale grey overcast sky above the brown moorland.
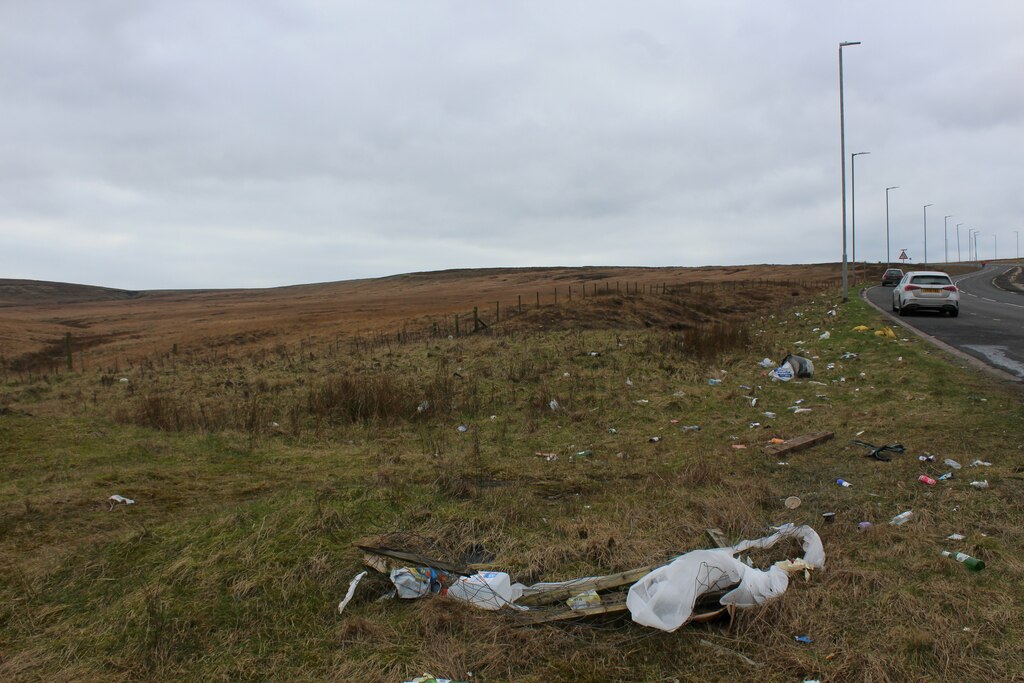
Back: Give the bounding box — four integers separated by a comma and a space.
0, 0, 1024, 289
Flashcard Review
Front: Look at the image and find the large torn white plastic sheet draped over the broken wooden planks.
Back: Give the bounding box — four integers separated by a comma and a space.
626, 524, 825, 632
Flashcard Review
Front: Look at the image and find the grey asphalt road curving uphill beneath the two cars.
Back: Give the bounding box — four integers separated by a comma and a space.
867, 264, 1024, 380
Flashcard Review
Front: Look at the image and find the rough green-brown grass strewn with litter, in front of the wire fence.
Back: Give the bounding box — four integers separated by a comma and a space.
0, 276, 1024, 683
